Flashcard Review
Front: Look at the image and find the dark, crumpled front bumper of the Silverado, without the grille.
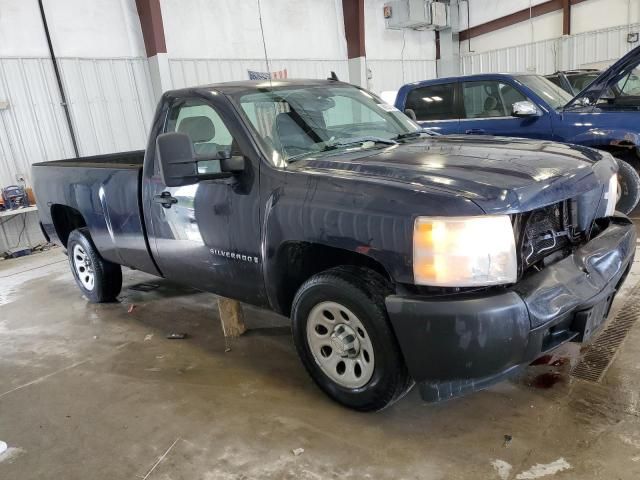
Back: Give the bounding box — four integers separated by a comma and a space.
386, 217, 636, 401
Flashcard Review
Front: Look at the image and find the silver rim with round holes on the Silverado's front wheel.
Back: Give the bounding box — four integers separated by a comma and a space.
307, 302, 375, 388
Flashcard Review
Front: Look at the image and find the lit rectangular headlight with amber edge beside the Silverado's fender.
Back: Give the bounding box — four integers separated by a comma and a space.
413, 215, 518, 287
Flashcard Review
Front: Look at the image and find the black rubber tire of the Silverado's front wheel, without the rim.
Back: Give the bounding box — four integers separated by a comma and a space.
291, 267, 414, 411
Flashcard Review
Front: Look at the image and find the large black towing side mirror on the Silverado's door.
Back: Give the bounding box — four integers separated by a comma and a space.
156, 132, 245, 187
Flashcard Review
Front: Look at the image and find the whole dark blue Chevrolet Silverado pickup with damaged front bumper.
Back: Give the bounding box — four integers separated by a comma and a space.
33, 80, 636, 411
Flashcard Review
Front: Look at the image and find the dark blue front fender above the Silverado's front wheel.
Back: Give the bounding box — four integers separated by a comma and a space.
262, 171, 484, 309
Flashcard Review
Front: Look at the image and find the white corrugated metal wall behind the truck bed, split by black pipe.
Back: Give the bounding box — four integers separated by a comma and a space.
0, 57, 155, 252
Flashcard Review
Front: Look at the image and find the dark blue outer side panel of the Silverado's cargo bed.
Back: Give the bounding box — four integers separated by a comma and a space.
33, 150, 158, 275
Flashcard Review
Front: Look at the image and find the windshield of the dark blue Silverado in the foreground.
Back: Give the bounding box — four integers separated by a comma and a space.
234, 82, 426, 166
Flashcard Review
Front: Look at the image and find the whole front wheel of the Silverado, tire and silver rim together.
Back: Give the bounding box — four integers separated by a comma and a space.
291, 267, 413, 411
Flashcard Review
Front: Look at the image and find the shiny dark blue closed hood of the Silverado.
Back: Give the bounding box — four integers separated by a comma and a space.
289, 135, 616, 213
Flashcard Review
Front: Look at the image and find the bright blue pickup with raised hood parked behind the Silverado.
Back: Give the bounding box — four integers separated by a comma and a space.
395, 47, 640, 213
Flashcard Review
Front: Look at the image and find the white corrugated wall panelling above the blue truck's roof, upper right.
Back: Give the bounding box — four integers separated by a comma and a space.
461, 24, 640, 75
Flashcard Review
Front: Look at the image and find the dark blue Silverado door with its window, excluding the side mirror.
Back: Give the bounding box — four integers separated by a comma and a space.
145, 98, 264, 304
